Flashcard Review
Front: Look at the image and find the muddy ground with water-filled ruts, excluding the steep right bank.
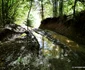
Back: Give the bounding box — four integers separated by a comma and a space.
0, 26, 85, 70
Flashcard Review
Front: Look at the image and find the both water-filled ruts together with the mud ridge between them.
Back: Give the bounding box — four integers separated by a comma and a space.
34, 30, 79, 58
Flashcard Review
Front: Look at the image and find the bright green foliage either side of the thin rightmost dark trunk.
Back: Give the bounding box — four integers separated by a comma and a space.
64, 0, 84, 15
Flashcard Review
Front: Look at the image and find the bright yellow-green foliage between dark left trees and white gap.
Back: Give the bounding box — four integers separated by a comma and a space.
14, 2, 29, 24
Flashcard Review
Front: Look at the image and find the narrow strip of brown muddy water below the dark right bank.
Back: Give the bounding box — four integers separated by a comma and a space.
48, 31, 79, 50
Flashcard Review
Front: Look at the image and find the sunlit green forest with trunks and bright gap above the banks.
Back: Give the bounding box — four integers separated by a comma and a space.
0, 0, 85, 27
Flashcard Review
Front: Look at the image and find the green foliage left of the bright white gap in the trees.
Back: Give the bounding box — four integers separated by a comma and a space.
0, 0, 30, 25
